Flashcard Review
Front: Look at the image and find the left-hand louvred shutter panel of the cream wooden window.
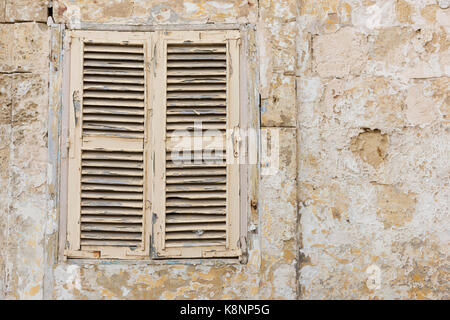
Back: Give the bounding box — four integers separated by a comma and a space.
68, 32, 149, 258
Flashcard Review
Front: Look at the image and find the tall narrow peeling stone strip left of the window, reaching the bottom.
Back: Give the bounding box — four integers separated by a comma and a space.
5, 73, 48, 299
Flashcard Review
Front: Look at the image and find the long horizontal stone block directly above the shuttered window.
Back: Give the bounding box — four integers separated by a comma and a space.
53, 0, 253, 24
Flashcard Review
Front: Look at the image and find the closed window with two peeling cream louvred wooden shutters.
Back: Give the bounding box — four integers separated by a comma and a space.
65, 31, 241, 259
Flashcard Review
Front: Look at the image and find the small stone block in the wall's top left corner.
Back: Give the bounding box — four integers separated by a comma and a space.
4, 0, 48, 22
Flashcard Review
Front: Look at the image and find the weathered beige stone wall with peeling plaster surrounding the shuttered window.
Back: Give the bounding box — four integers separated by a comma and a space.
0, 0, 450, 299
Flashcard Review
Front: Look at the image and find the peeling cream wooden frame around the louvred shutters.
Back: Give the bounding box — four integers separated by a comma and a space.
59, 30, 254, 263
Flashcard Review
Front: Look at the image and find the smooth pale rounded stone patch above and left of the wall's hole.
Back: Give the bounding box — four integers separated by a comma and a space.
313, 28, 368, 78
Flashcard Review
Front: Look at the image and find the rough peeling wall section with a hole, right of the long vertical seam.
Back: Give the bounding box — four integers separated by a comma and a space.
297, 0, 450, 299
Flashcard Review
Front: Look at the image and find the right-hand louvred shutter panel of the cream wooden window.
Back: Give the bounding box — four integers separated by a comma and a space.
153, 32, 240, 258
